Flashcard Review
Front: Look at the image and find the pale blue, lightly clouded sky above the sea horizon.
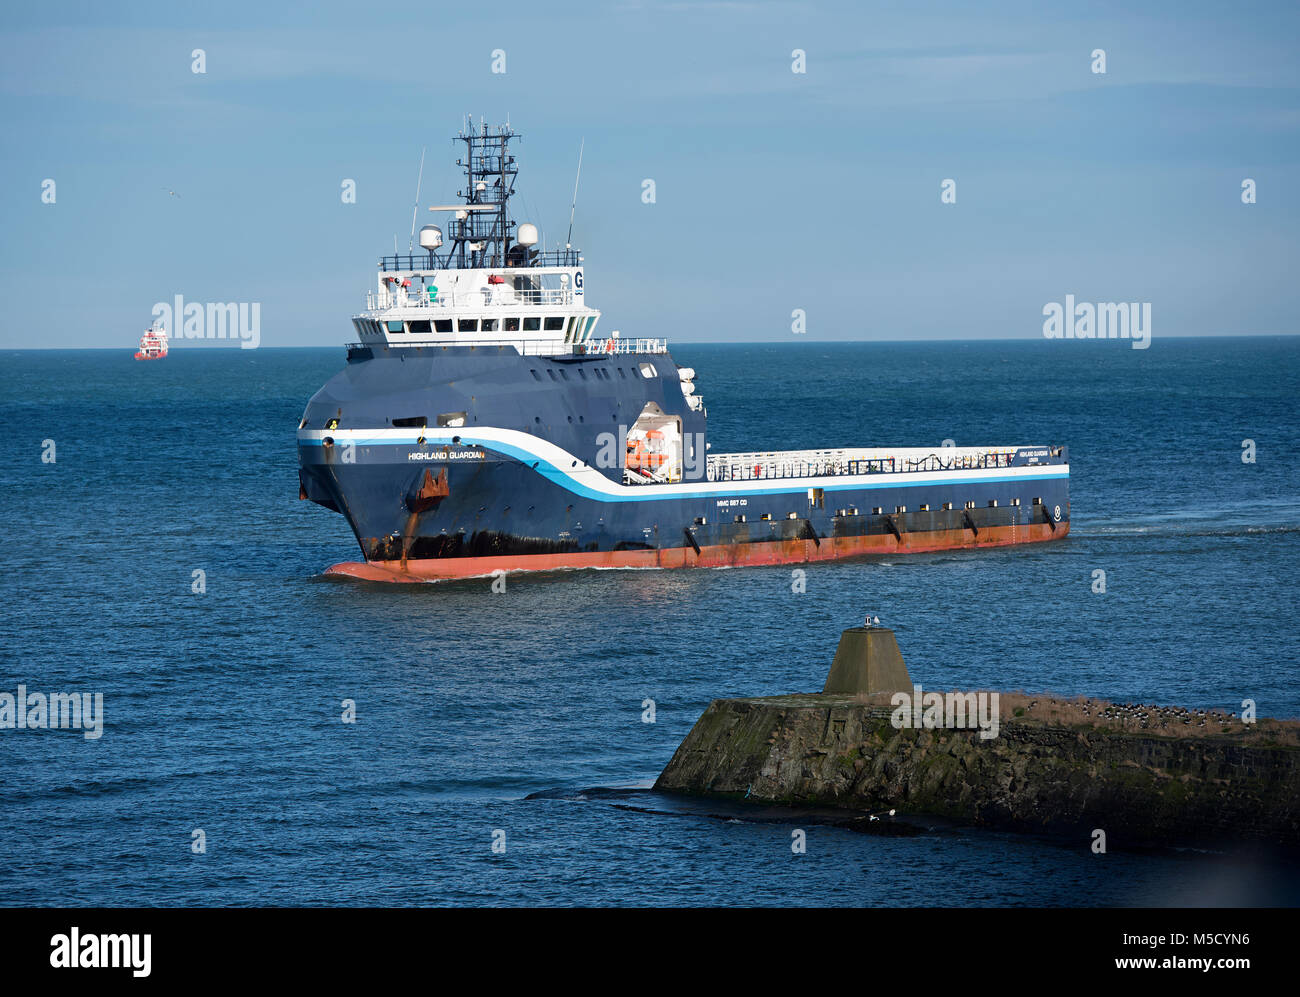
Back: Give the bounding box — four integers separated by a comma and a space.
0, 1, 1300, 347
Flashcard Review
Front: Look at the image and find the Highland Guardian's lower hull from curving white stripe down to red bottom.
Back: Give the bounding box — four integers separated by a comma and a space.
299, 428, 1070, 581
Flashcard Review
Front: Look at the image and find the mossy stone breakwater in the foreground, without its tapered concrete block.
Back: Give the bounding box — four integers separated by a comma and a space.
655, 693, 1300, 848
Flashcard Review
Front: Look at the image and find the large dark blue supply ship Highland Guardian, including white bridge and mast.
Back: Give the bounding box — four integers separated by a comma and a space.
298, 122, 1070, 581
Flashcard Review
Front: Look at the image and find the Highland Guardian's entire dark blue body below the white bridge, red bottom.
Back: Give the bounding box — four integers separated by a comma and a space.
298, 347, 1070, 581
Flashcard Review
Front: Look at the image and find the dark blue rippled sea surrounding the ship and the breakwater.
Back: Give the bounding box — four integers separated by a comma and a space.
0, 338, 1300, 906
